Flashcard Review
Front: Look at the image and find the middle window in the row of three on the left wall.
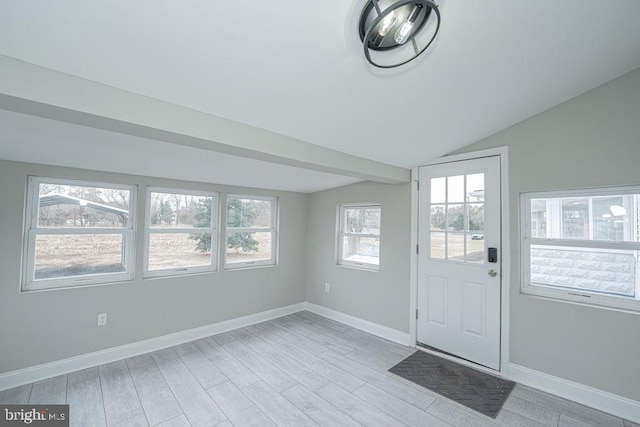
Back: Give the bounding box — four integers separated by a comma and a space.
144, 188, 218, 277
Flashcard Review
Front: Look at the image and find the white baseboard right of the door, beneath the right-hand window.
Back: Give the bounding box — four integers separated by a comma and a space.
509, 363, 640, 423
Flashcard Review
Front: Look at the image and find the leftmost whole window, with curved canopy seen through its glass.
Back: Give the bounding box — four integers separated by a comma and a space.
22, 177, 135, 291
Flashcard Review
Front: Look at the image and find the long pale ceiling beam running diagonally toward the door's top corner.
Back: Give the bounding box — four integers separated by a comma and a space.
0, 55, 409, 184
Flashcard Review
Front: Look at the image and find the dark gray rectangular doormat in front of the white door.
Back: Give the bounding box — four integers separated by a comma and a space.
389, 351, 515, 418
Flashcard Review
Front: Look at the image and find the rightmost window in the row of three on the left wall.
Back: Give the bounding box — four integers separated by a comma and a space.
225, 195, 278, 269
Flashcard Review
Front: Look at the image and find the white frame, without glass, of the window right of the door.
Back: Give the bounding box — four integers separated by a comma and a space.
520, 186, 640, 313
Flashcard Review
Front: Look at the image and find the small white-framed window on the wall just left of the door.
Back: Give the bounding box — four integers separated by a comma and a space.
338, 203, 382, 270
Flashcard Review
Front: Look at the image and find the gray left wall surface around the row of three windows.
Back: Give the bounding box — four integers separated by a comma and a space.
0, 160, 308, 373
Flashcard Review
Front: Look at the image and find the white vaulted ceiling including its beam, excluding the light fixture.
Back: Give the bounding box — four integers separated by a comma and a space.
0, 0, 640, 192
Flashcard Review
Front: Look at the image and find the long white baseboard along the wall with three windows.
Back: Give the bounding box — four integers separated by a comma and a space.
0, 302, 305, 390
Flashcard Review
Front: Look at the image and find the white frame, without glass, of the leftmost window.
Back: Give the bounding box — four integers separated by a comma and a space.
21, 176, 137, 292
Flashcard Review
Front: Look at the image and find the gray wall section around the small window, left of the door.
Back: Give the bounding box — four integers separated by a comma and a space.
306, 182, 411, 333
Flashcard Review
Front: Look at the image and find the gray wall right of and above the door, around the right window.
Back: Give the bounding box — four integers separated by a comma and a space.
448, 70, 640, 401
